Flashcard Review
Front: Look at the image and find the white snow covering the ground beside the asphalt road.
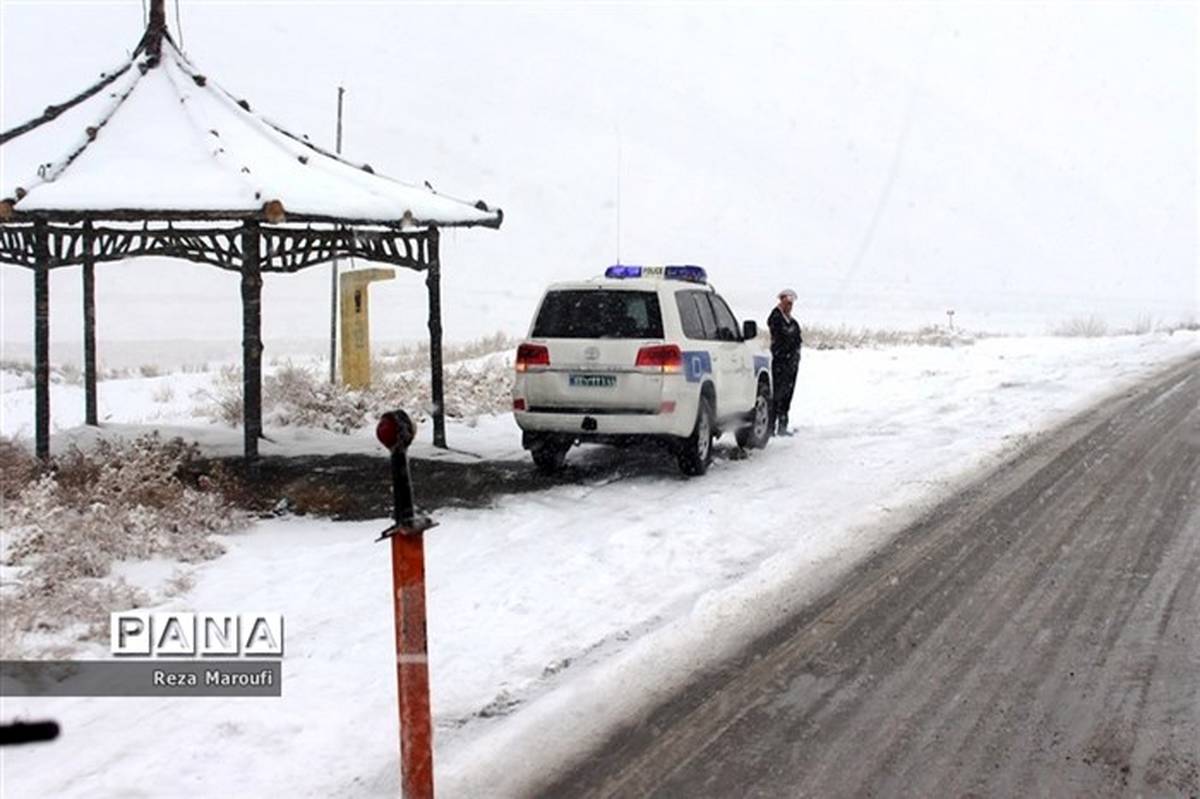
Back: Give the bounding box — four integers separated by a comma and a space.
0, 331, 1200, 799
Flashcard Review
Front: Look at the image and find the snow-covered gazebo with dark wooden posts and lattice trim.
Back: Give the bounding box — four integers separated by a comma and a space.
0, 0, 504, 457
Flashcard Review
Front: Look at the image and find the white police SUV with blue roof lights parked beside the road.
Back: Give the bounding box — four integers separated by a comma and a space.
512, 266, 770, 475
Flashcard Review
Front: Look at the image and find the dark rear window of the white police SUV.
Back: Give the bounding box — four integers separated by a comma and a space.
533, 289, 662, 338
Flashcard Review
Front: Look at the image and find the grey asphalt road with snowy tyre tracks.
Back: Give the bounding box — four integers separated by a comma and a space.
544, 359, 1200, 799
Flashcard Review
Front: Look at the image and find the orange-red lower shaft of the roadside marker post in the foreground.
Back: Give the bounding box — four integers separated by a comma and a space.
390, 529, 433, 799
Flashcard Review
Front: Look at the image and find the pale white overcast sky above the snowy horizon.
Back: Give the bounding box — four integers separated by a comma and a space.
0, 0, 1200, 349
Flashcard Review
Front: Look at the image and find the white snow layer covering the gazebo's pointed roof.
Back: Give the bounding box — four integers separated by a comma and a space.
0, 35, 504, 227
